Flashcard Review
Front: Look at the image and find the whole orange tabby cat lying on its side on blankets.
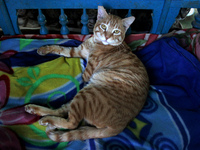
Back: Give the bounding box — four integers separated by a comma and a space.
25, 6, 149, 142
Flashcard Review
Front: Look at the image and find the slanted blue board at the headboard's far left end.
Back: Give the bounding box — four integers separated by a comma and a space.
0, 0, 15, 35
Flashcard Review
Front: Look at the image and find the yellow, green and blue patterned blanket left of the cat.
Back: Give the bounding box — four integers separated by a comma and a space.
0, 39, 83, 149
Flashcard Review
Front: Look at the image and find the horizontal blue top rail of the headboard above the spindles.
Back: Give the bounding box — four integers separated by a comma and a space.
5, 0, 164, 9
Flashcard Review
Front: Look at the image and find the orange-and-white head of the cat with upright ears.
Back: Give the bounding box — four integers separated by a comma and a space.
93, 6, 135, 46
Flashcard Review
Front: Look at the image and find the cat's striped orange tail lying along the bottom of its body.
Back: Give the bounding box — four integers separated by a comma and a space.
47, 126, 123, 142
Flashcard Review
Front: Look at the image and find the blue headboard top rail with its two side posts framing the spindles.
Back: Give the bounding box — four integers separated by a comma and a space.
5, 0, 168, 34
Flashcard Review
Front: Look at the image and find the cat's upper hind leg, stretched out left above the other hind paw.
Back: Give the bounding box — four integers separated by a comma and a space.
25, 104, 68, 116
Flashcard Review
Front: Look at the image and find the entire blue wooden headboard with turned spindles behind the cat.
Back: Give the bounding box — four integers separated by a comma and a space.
0, 0, 200, 35
